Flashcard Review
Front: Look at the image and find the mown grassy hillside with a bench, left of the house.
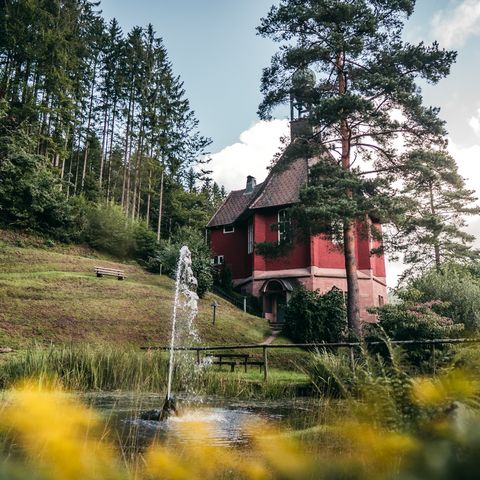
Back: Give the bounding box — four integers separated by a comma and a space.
0, 231, 268, 347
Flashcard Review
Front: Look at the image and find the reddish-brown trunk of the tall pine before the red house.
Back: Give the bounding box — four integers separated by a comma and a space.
337, 53, 362, 335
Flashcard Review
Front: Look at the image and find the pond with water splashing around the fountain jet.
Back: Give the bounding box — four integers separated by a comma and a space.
83, 393, 318, 453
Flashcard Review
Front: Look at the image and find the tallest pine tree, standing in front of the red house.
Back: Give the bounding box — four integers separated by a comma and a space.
258, 0, 456, 334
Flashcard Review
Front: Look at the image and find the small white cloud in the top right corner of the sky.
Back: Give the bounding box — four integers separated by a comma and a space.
432, 0, 480, 48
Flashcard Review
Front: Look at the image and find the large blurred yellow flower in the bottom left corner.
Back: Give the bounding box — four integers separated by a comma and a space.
0, 382, 124, 480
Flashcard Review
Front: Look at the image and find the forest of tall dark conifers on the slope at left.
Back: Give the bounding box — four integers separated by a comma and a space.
0, 0, 224, 248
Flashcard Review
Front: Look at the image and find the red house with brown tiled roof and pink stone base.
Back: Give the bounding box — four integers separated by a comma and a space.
207, 137, 387, 322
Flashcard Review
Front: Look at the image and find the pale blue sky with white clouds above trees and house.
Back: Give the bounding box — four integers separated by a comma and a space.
100, 0, 480, 285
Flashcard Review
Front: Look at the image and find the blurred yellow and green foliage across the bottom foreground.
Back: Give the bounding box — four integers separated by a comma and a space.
0, 364, 480, 480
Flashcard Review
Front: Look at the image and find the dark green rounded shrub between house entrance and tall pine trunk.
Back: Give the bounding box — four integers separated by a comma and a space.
284, 287, 347, 343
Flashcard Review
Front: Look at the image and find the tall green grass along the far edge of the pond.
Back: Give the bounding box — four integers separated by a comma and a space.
0, 345, 305, 399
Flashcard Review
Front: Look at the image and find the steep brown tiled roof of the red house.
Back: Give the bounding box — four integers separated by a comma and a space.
207, 158, 308, 227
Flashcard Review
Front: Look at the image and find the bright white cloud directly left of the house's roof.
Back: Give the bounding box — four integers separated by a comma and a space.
209, 120, 289, 191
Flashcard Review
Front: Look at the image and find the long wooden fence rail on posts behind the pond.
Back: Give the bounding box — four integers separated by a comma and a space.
140, 338, 480, 381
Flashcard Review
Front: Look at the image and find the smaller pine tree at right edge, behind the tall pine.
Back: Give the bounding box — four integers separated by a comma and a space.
398, 149, 480, 274
